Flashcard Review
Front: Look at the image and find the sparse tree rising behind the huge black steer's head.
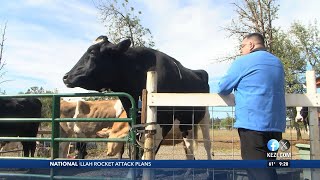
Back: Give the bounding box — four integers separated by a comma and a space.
97, 0, 155, 47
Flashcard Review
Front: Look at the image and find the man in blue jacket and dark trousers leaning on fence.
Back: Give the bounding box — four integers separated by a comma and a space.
218, 33, 286, 180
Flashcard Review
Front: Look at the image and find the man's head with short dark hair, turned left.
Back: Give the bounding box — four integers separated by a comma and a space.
240, 33, 265, 55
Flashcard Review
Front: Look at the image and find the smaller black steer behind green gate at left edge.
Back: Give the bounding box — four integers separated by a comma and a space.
0, 97, 42, 157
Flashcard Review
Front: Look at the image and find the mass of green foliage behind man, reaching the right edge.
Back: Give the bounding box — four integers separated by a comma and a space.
225, 0, 320, 93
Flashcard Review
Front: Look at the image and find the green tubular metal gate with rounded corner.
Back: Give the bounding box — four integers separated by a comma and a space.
0, 92, 138, 179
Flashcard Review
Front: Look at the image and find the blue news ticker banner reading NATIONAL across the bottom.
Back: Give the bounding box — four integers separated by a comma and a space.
0, 159, 320, 169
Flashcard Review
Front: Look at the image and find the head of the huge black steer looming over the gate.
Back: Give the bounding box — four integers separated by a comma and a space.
63, 36, 131, 91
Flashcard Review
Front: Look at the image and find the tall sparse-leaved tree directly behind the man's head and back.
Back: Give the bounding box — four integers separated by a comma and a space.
225, 0, 306, 139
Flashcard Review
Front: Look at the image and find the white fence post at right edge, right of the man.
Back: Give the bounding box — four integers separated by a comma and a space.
306, 71, 320, 179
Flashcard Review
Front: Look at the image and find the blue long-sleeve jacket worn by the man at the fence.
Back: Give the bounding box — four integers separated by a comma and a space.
218, 50, 286, 132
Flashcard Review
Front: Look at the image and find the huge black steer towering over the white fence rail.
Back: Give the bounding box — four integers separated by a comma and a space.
63, 36, 210, 159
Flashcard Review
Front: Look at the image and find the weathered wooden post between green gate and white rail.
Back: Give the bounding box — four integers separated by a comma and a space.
142, 71, 158, 180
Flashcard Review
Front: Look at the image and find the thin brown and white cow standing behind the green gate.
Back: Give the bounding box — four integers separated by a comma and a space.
59, 100, 126, 158
